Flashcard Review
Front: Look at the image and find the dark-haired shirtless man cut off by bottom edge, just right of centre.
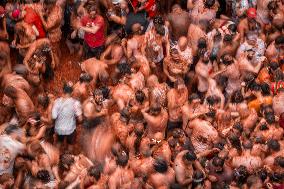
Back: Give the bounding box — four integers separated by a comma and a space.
147, 159, 175, 189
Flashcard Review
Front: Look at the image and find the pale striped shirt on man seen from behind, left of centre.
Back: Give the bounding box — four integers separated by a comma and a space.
52, 97, 82, 135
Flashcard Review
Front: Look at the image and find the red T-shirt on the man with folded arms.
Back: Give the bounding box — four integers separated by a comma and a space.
81, 15, 105, 48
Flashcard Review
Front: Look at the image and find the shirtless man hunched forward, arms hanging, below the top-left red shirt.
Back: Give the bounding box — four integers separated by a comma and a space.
23, 38, 55, 86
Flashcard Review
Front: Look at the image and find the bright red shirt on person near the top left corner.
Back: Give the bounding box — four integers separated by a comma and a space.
24, 7, 45, 39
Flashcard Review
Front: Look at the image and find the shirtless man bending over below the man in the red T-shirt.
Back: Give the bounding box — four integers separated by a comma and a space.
80, 58, 109, 88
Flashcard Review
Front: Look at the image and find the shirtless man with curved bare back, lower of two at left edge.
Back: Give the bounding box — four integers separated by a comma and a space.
4, 86, 35, 125
